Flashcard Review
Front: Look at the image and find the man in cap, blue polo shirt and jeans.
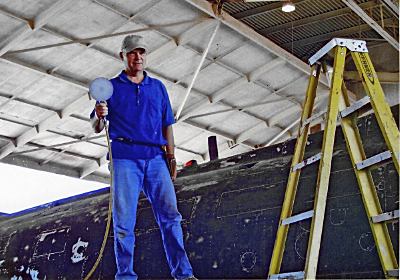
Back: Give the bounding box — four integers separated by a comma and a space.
91, 35, 196, 280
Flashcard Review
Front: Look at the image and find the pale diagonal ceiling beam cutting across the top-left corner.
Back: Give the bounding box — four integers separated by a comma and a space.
0, 0, 74, 56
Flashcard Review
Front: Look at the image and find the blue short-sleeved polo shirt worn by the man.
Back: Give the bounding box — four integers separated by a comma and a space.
91, 71, 175, 159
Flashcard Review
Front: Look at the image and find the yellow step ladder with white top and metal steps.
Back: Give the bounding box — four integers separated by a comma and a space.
268, 38, 400, 279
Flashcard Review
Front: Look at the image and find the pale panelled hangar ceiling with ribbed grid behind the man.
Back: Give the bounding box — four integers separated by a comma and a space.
0, 0, 378, 182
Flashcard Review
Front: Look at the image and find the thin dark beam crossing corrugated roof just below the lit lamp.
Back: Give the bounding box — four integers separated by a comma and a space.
257, 0, 377, 36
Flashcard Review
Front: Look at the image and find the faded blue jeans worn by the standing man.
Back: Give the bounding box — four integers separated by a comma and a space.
112, 155, 193, 280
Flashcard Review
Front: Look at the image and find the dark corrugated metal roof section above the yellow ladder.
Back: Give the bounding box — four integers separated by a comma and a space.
223, 0, 398, 61
